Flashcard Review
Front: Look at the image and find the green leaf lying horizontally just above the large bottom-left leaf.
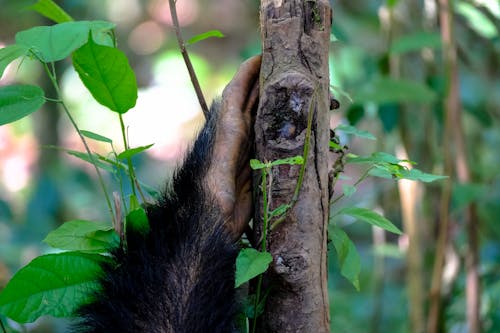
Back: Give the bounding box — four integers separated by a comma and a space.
43, 220, 118, 253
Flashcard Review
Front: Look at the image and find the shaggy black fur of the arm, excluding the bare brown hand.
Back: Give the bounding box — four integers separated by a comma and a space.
75, 102, 237, 333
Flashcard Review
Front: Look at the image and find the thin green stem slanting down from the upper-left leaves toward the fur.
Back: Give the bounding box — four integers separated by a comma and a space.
43, 63, 116, 225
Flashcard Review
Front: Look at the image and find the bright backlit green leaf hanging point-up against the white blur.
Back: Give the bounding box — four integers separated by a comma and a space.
73, 38, 137, 113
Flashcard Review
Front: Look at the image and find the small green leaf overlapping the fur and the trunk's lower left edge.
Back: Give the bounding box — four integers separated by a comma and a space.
235, 248, 273, 288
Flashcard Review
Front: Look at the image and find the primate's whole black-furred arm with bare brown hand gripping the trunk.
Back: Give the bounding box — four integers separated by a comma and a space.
74, 57, 260, 333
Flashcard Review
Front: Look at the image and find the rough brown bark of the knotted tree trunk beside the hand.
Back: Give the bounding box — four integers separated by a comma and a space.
255, 0, 332, 333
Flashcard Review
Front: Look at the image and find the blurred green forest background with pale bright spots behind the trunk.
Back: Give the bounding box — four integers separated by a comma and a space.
0, 0, 500, 333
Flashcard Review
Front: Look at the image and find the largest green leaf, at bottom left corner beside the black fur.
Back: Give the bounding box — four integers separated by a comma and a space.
0, 252, 106, 323
